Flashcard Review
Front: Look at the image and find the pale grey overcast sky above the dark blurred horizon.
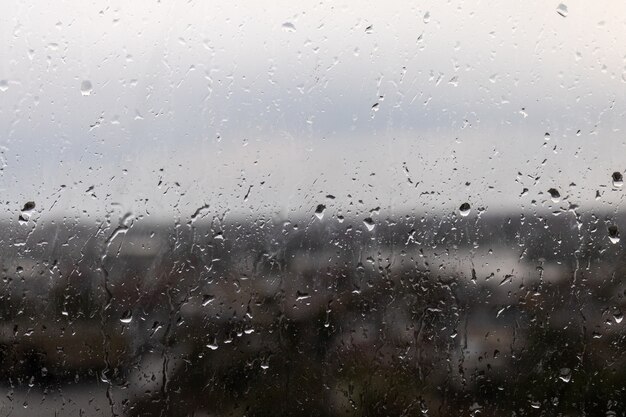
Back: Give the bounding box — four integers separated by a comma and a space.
0, 0, 626, 224
